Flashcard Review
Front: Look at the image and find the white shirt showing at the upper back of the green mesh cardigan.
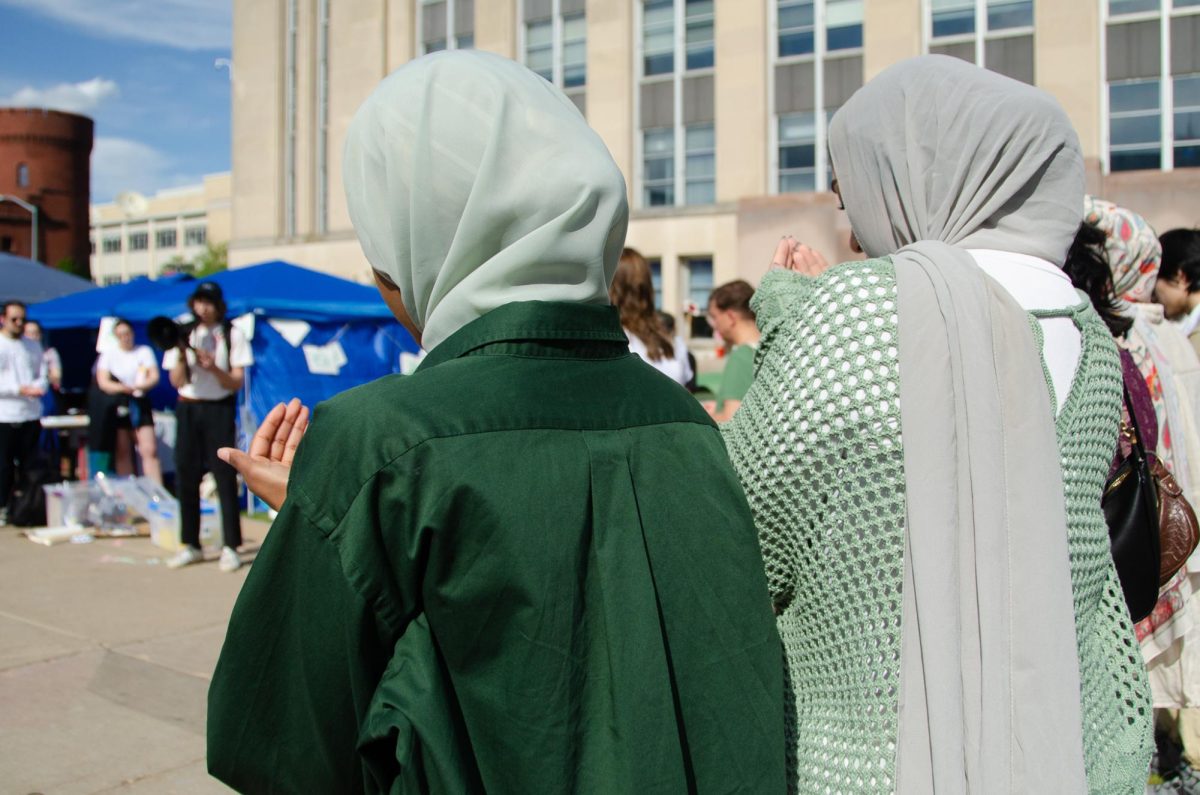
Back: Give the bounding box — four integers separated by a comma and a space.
967, 249, 1085, 413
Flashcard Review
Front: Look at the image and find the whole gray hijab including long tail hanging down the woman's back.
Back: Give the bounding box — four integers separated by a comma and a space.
829, 55, 1099, 793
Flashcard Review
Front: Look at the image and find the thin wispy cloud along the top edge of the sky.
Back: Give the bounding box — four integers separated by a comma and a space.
0, 0, 233, 49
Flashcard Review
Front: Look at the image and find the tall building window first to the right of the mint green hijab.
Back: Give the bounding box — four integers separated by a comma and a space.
635, 0, 716, 207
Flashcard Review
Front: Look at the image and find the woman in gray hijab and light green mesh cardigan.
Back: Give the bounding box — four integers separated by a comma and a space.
725, 56, 1151, 793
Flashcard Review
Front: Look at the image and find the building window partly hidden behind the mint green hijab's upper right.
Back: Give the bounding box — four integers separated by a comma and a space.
521, 0, 588, 113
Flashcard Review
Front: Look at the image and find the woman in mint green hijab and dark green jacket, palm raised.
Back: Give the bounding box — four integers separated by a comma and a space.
208, 52, 785, 794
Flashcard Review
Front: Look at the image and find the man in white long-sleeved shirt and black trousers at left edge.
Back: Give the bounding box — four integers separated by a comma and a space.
0, 301, 48, 525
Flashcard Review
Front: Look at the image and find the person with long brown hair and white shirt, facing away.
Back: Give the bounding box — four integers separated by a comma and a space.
608, 249, 694, 387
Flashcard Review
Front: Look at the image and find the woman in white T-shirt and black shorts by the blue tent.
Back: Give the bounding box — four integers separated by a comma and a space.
96, 318, 162, 483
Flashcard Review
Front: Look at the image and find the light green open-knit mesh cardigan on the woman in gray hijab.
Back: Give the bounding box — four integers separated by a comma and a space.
722, 258, 1150, 793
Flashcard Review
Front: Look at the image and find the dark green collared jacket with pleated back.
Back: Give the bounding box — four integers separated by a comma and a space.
209, 301, 785, 794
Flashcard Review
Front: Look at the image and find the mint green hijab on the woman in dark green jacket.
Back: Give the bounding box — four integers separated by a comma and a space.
343, 50, 629, 349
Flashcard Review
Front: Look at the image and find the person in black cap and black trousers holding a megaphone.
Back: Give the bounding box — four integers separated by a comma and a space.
162, 287, 254, 572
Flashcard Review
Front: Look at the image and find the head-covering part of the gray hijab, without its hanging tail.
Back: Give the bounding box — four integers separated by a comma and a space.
829, 55, 1084, 265
